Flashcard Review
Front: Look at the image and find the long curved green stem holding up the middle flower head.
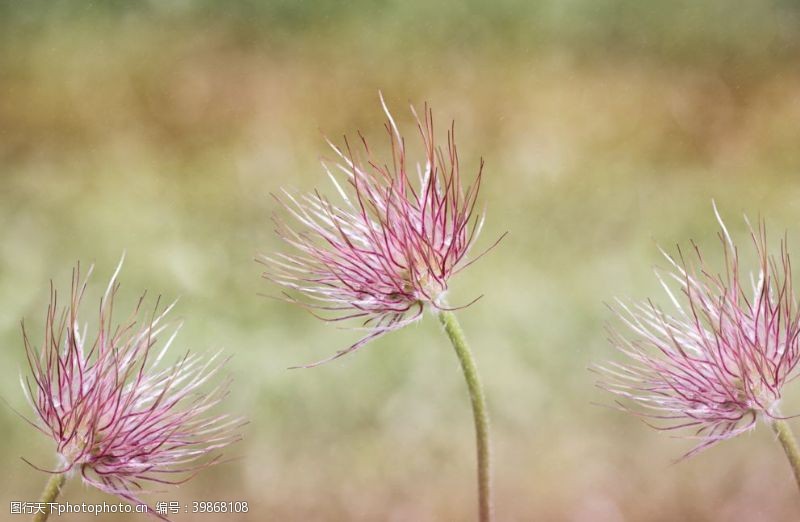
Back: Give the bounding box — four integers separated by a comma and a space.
438, 310, 492, 522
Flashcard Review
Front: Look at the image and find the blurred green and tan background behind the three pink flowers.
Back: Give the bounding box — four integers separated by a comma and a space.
0, 0, 800, 522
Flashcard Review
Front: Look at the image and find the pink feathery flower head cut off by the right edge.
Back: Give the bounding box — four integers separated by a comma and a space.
598, 207, 800, 457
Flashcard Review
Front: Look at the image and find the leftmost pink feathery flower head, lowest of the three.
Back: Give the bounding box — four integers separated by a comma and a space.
22, 262, 243, 518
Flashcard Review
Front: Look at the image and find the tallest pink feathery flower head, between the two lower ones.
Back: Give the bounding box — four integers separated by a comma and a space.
259, 96, 499, 366
